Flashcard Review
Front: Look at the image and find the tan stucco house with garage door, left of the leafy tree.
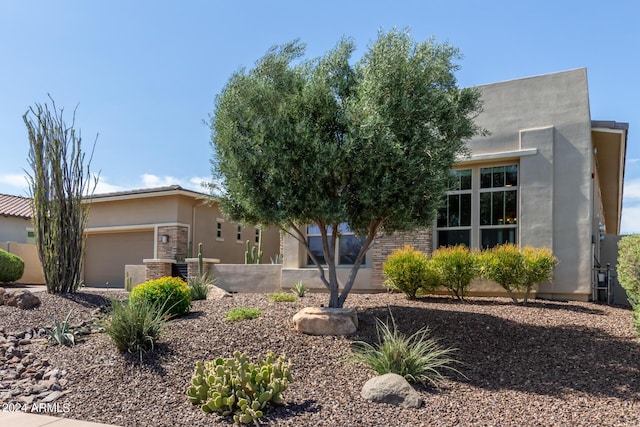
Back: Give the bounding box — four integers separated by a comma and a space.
84, 185, 280, 287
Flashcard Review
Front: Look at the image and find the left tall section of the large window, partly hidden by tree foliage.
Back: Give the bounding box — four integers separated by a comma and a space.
437, 169, 472, 246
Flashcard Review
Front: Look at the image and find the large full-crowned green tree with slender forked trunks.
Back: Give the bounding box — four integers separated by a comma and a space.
211, 30, 482, 307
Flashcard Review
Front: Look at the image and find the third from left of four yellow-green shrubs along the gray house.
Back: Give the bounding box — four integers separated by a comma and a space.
478, 243, 526, 303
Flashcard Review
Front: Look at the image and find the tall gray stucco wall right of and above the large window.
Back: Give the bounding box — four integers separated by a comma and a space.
469, 69, 593, 299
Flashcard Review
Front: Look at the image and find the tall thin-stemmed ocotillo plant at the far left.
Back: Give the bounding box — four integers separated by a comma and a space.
23, 97, 97, 294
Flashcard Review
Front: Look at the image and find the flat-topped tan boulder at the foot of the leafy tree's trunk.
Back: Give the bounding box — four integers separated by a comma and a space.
293, 307, 358, 335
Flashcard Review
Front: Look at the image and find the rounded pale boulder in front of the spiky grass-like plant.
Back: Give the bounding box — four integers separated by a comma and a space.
360, 373, 422, 408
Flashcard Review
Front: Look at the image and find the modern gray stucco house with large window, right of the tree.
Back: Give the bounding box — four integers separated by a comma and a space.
282, 68, 628, 300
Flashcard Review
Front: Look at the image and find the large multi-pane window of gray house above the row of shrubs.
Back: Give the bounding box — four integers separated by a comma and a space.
436, 165, 518, 249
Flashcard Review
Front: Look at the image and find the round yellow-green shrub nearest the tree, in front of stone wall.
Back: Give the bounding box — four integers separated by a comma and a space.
382, 246, 439, 299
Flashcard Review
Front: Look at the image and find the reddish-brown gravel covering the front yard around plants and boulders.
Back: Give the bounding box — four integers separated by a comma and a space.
0, 292, 640, 427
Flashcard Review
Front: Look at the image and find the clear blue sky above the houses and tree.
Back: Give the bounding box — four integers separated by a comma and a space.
0, 0, 640, 233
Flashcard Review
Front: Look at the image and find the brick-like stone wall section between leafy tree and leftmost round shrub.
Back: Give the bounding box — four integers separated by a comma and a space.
371, 229, 433, 285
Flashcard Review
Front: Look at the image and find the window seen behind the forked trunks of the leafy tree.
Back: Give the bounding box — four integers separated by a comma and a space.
307, 223, 366, 265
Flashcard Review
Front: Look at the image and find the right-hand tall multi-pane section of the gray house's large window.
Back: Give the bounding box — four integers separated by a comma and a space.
480, 165, 518, 249
